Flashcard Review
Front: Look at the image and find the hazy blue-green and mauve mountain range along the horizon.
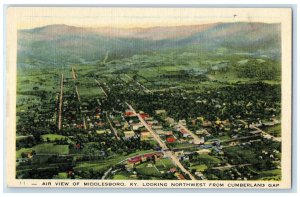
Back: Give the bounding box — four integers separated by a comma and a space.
18, 22, 281, 65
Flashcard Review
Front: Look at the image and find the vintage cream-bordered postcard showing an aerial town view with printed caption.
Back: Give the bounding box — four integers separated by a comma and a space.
6, 6, 292, 189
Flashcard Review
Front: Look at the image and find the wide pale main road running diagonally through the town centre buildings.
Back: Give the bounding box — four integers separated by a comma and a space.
126, 103, 196, 180
